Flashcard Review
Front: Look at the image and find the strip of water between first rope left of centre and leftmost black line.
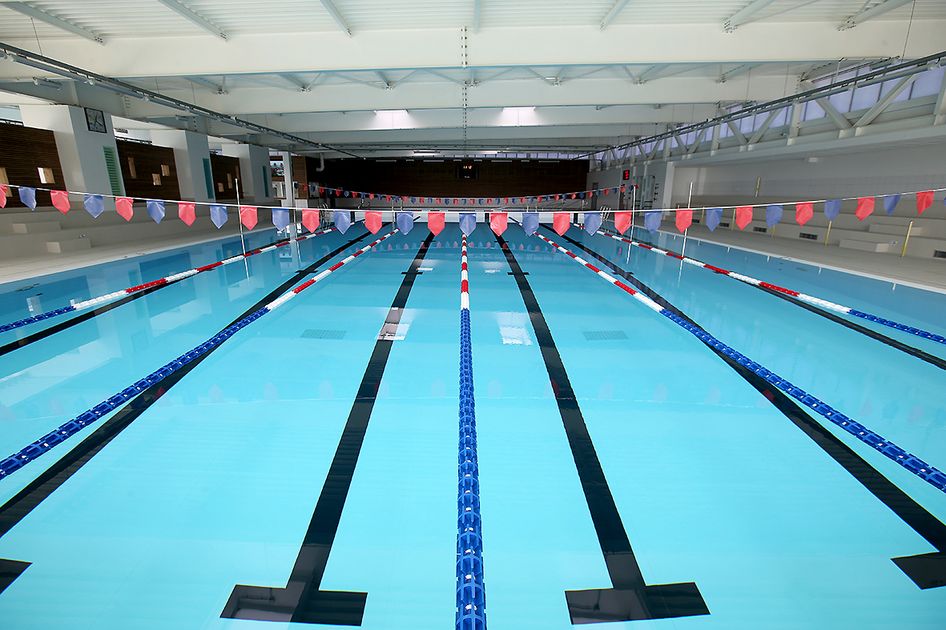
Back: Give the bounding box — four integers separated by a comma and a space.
0, 227, 368, 500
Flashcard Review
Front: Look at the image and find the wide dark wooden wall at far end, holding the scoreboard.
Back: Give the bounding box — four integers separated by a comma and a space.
308, 158, 588, 197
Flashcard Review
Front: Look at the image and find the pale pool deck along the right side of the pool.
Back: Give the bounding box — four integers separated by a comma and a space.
648, 226, 946, 293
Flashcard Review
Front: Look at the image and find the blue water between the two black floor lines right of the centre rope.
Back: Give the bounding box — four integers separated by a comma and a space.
494, 231, 946, 629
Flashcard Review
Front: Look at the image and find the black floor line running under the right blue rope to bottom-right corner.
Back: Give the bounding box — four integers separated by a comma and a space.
564, 231, 946, 589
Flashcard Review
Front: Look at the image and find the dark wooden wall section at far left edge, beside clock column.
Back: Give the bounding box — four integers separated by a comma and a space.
0, 123, 65, 208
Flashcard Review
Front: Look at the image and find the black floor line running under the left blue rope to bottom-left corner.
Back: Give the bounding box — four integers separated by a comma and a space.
0, 232, 370, 593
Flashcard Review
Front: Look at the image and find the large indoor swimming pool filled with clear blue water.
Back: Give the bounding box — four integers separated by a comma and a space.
0, 218, 946, 630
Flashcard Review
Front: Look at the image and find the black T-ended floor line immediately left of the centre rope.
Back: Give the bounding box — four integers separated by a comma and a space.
220, 234, 434, 626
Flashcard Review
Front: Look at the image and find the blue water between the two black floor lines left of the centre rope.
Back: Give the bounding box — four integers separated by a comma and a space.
0, 228, 428, 628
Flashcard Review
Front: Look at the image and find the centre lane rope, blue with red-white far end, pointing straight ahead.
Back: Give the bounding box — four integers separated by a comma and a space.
456, 236, 486, 630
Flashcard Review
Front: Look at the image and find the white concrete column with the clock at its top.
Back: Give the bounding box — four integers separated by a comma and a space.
20, 105, 125, 195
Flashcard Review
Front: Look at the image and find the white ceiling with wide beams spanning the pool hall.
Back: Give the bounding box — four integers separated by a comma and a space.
0, 0, 946, 155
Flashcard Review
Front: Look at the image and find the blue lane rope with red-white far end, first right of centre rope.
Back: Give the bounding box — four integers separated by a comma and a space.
536, 233, 946, 492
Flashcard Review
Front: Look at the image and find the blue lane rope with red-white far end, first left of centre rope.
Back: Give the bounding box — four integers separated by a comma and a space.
0, 228, 398, 480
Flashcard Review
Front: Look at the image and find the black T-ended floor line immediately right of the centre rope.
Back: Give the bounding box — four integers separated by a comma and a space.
496, 236, 709, 624
